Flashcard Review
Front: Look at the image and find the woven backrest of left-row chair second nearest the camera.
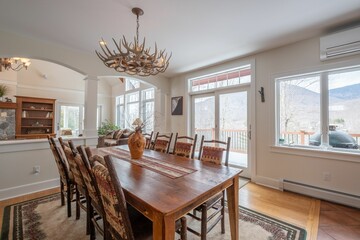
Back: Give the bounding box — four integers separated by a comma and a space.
75, 146, 101, 207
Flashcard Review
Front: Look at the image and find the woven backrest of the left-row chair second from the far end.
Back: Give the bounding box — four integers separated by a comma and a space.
59, 137, 85, 188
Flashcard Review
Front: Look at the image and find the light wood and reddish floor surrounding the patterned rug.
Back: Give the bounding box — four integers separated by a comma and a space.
0, 183, 360, 240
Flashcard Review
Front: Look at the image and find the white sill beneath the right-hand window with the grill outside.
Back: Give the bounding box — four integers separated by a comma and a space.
270, 145, 360, 163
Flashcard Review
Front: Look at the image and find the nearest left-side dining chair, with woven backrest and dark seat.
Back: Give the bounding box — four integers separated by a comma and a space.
92, 155, 187, 240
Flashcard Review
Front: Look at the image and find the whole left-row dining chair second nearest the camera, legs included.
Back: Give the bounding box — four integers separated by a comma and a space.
75, 145, 107, 240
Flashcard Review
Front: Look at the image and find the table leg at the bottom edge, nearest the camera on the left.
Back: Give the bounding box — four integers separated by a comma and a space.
153, 213, 175, 240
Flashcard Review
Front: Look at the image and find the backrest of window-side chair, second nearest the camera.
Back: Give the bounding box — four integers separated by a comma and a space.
173, 133, 197, 159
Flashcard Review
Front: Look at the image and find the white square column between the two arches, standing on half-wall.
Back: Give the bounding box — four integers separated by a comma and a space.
84, 76, 98, 137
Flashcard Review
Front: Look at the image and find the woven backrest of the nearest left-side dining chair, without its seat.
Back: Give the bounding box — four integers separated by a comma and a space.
92, 156, 134, 240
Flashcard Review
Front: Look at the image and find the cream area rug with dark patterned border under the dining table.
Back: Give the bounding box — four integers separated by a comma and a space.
0, 194, 306, 240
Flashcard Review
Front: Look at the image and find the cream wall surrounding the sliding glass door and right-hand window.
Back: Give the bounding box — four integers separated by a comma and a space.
168, 38, 360, 200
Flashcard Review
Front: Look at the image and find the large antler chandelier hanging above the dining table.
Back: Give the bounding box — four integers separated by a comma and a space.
95, 8, 171, 77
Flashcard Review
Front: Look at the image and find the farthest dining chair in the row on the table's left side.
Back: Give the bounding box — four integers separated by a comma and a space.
47, 135, 75, 217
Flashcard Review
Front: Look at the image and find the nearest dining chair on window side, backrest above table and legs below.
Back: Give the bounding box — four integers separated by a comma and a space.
188, 136, 231, 240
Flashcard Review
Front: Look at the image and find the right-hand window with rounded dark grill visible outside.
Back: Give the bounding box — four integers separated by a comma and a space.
276, 67, 360, 152
